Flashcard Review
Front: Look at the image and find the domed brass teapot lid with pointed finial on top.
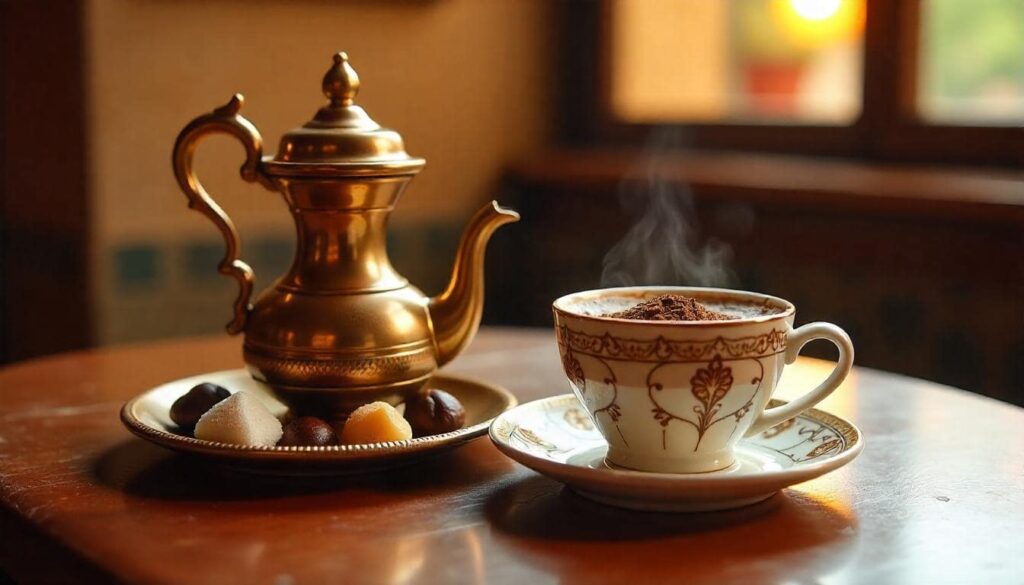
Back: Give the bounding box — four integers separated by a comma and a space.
263, 52, 426, 176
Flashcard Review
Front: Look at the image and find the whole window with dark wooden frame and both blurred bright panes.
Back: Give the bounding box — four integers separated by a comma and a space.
563, 0, 1024, 165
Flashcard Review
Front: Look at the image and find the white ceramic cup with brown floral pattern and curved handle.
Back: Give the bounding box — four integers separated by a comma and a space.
553, 287, 853, 473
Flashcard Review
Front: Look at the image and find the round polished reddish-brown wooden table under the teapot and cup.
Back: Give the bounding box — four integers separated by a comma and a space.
0, 330, 1024, 585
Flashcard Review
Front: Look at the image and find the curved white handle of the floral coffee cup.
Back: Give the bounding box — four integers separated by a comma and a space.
746, 323, 853, 436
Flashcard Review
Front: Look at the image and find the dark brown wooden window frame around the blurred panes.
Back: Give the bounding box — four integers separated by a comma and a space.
561, 0, 1024, 166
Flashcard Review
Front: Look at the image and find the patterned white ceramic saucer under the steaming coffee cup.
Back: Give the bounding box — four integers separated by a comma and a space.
490, 394, 863, 512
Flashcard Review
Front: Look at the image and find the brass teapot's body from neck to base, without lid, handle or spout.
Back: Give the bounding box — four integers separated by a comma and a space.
243, 176, 437, 416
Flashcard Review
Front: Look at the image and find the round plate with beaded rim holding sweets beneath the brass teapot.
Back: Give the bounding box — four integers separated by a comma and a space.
121, 370, 516, 475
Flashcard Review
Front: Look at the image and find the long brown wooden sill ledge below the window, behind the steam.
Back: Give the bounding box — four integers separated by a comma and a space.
510, 149, 1024, 227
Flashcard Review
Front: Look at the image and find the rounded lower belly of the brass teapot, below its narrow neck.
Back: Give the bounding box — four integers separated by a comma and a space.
243, 285, 437, 418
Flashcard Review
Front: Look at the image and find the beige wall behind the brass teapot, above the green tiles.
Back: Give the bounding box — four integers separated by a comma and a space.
86, 0, 552, 342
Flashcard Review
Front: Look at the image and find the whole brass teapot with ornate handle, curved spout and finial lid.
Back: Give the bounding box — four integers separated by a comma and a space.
173, 53, 519, 419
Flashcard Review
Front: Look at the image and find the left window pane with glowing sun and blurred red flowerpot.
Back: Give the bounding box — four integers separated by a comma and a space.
610, 0, 864, 124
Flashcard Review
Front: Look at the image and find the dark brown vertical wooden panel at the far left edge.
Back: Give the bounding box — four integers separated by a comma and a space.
0, 0, 92, 363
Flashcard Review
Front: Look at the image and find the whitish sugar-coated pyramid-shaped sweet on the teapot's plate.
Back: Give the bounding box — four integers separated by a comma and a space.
196, 392, 284, 447
